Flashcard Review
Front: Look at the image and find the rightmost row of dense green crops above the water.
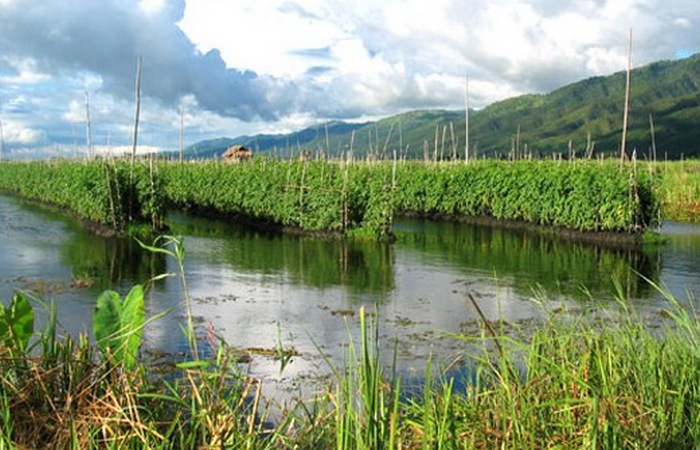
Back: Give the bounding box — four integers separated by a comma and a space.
396, 161, 659, 232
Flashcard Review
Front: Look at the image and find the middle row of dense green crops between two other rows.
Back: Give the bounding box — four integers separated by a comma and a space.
159, 158, 392, 238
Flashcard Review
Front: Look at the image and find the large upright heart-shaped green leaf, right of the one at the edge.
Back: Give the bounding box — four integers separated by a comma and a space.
93, 284, 146, 369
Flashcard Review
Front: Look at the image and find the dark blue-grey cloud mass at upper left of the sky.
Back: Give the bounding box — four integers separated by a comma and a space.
0, 0, 289, 120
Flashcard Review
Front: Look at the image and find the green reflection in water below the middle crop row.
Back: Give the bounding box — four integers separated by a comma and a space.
169, 216, 394, 293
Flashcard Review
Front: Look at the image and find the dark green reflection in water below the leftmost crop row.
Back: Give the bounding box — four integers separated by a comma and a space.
61, 233, 166, 289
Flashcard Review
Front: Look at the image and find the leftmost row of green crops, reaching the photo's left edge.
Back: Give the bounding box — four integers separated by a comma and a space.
0, 161, 165, 231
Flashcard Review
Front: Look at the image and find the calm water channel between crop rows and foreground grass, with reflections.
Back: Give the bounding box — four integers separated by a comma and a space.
0, 196, 700, 400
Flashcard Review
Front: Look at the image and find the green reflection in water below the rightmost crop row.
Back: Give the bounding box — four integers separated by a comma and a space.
397, 221, 659, 297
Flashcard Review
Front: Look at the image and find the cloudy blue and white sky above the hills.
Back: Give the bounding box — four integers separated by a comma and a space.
0, 0, 700, 157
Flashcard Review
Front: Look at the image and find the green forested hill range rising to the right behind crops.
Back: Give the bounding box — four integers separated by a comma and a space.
179, 54, 700, 159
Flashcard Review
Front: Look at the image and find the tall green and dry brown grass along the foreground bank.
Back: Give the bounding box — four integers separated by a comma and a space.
0, 238, 700, 450
